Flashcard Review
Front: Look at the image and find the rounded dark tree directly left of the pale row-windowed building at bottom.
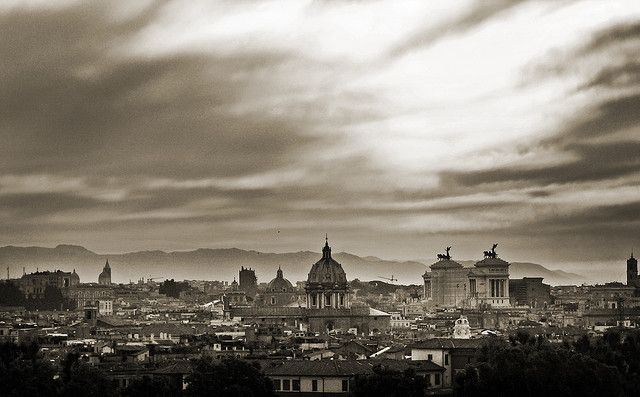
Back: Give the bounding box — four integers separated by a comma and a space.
186, 357, 275, 397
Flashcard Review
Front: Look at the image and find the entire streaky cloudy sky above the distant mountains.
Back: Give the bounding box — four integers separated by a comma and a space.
0, 0, 640, 274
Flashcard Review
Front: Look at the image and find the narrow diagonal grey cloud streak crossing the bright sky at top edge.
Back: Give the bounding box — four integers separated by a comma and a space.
390, 0, 525, 56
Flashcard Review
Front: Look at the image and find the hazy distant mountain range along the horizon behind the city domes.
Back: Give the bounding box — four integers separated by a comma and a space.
0, 245, 586, 285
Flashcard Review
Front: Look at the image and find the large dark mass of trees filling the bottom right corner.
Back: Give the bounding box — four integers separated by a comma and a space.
454, 331, 640, 397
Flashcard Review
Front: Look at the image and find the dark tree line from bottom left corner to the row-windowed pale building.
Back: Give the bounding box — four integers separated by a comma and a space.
0, 343, 275, 397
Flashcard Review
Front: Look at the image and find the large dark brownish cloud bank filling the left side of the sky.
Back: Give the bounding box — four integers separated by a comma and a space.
0, 1, 312, 176
